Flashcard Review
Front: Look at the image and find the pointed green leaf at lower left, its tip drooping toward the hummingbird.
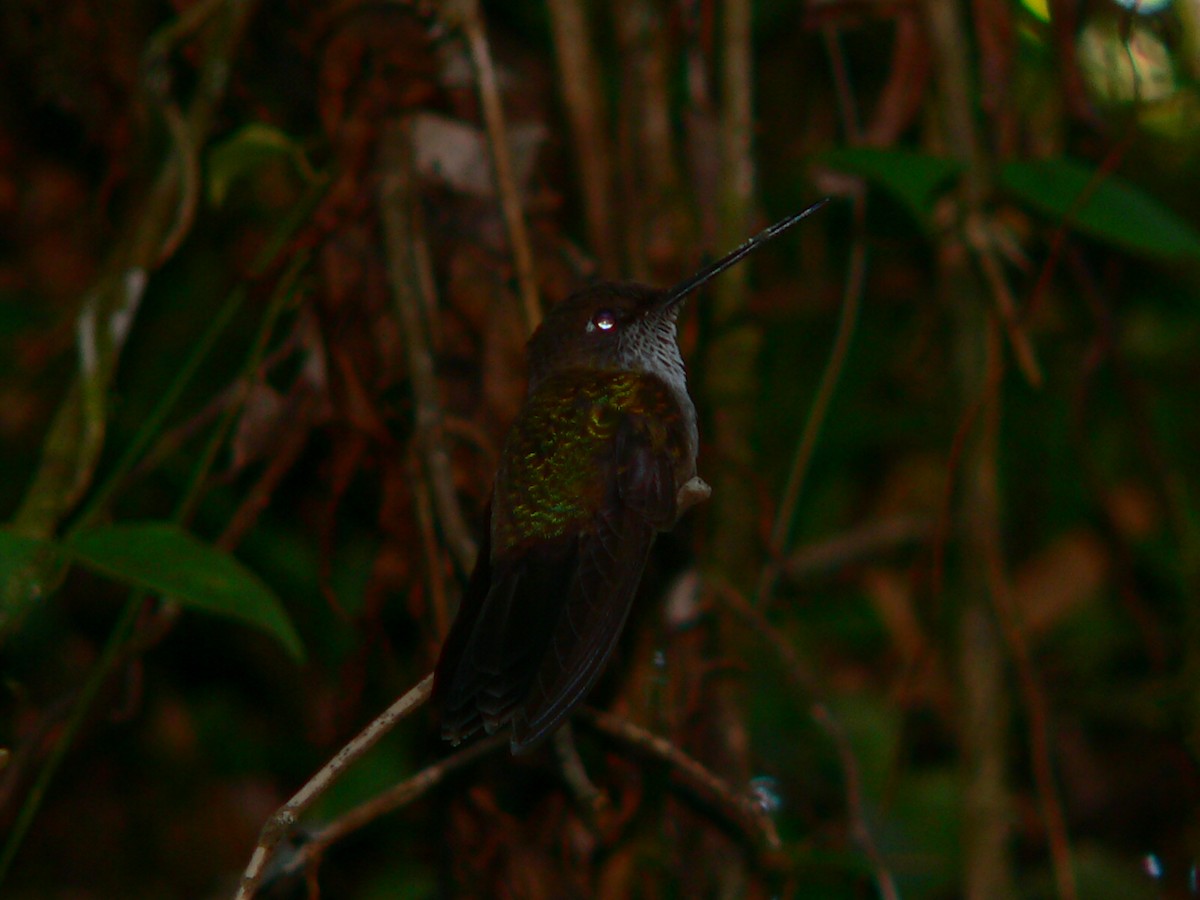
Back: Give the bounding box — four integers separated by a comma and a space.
65, 522, 304, 660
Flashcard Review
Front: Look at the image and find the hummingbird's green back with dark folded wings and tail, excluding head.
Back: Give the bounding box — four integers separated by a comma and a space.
434, 372, 695, 751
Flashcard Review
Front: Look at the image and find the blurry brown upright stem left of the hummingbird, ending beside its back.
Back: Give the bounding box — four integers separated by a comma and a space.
379, 121, 475, 571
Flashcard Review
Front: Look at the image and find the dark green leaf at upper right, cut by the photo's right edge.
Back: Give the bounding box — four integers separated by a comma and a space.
1000, 160, 1200, 260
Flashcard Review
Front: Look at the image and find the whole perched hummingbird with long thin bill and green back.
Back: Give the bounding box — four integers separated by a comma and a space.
433, 200, 828, 754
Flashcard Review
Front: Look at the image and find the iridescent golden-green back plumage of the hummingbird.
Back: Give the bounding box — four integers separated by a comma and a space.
492, 371, 691, 556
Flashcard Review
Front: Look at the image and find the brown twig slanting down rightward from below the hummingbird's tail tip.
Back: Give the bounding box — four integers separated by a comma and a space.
575, 707, 782, 851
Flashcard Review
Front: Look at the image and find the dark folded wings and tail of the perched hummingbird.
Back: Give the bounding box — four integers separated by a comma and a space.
434, 408, 676, 751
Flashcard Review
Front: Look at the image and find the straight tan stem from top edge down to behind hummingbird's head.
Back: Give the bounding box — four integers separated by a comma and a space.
440, 0, 541, 334
